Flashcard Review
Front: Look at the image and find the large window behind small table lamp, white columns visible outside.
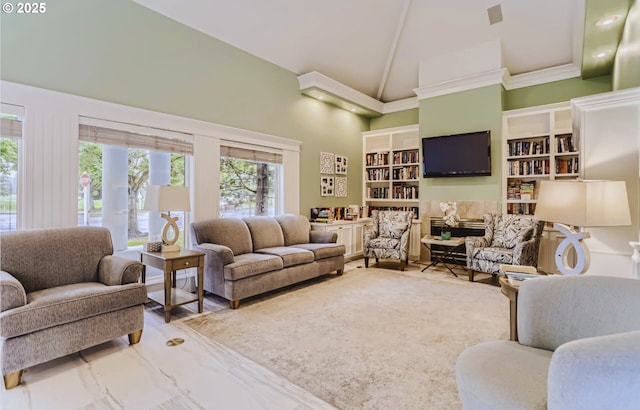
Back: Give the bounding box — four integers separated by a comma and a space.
78, 124, 193, 251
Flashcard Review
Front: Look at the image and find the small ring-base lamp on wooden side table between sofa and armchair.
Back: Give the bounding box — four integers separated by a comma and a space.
143, 185, 191, 252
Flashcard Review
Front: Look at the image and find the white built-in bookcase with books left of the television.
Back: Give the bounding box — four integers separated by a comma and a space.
362, 125, 421, 219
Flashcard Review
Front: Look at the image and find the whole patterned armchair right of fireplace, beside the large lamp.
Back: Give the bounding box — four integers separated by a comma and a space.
465, 214, 544, 282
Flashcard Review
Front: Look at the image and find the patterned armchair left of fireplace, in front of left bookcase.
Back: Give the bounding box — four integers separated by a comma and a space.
364, 211, 413, 271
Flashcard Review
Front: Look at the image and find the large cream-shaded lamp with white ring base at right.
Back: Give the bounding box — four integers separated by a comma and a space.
534, 181, 631, 275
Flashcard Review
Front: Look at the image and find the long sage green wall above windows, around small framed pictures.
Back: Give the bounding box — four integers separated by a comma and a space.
0, 0, 369, 214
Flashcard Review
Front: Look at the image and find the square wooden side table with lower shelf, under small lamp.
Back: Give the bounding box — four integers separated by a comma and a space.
140, 249, 204, 323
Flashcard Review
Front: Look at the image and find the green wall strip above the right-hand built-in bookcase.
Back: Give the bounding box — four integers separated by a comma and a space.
504, 75, 611, 111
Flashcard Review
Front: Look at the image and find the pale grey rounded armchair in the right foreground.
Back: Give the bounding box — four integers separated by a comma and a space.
456, 275, 640, 410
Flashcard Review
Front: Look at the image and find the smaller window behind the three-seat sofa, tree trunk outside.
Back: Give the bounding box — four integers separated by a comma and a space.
220, 146, 282, 218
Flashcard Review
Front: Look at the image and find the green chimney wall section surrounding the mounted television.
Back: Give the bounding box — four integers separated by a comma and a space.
420, 84, 502, 201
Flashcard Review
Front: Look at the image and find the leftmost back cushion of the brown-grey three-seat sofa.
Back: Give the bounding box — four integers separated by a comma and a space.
191, 218, 253, 255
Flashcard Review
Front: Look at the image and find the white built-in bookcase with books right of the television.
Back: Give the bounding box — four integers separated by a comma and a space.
502, 103, 581, 215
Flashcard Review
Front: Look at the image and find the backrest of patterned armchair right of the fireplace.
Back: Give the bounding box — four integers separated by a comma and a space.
484, 214, 544, 249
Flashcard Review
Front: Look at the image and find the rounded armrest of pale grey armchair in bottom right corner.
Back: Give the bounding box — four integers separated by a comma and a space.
547, 331, 640, 410
